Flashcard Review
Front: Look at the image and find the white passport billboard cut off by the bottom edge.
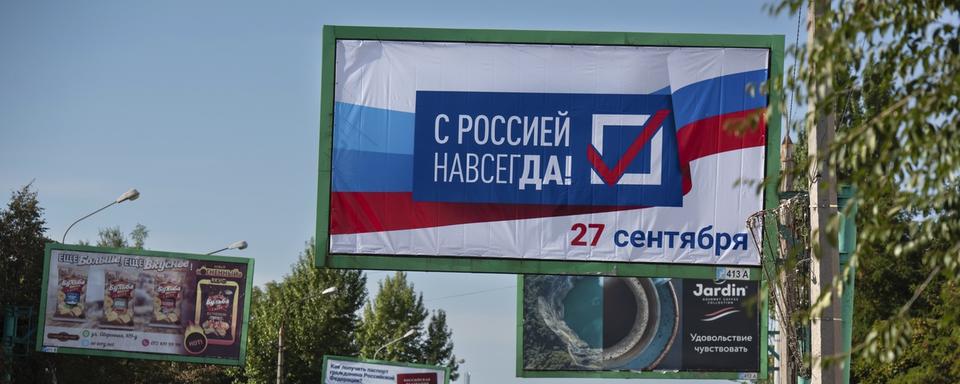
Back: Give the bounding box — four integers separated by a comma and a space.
320, 356, 450, 384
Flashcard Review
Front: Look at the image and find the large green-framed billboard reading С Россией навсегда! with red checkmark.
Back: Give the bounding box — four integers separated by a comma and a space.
317, 26, 782, 273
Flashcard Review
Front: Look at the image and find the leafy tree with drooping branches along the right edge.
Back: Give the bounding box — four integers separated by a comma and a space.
773, 0, 960, 382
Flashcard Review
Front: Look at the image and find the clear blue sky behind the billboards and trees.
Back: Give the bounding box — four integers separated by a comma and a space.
0, 0, 797, 383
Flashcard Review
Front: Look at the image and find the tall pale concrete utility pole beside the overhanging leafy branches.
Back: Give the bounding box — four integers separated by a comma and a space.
807, 0, 843, 384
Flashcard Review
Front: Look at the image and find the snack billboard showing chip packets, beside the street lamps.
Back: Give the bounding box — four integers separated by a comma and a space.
37, 243, 253, 365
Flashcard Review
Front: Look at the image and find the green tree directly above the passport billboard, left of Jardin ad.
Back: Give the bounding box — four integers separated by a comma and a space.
357, 272, 459, 379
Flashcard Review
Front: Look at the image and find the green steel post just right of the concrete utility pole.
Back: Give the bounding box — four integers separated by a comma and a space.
837, 185, 858, 383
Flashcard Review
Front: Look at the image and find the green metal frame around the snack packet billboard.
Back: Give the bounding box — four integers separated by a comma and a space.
36, 243, 254, 365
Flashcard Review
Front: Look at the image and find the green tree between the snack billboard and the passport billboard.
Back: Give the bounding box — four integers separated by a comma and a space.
242, 240, 367, 383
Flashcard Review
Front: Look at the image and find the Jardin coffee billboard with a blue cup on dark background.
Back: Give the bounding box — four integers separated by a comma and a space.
517, 269, 765, 379
